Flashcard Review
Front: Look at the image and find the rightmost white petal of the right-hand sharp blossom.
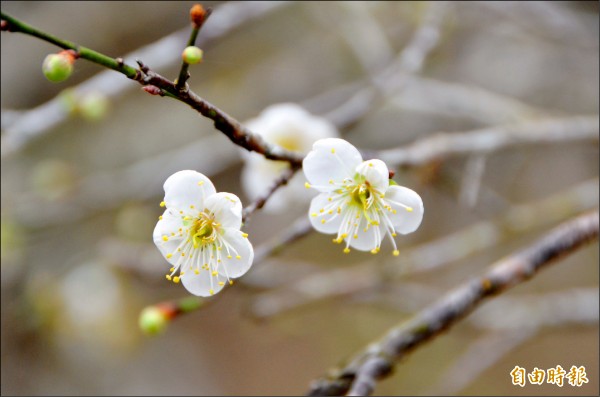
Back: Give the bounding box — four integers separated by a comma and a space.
384, 185, 424, 234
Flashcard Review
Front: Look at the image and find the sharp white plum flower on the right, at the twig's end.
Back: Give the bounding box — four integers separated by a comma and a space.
302, 138, 424, 255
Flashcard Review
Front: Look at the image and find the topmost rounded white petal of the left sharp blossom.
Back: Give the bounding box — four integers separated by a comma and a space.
164, 170, 216, 214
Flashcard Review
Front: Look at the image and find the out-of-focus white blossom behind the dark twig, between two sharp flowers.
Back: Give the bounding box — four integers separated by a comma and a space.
242, 103, 338, 213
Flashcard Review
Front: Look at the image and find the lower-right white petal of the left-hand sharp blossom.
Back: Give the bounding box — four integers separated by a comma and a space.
218, 229, 254, 278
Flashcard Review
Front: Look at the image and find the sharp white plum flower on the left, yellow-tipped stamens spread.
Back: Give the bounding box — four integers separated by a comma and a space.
153, 170, 254, 296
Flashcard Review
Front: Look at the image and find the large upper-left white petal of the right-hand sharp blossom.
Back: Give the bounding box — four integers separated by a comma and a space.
302, 138, 362, 191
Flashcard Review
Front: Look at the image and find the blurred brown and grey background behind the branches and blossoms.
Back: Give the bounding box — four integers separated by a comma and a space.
1, 1, 599, 395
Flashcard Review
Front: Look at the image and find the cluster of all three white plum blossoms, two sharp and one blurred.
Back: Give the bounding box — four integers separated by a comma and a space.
153, 104, 424, 296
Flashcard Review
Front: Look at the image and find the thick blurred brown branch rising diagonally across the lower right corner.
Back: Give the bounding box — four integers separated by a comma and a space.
309, 210, 598, 395
